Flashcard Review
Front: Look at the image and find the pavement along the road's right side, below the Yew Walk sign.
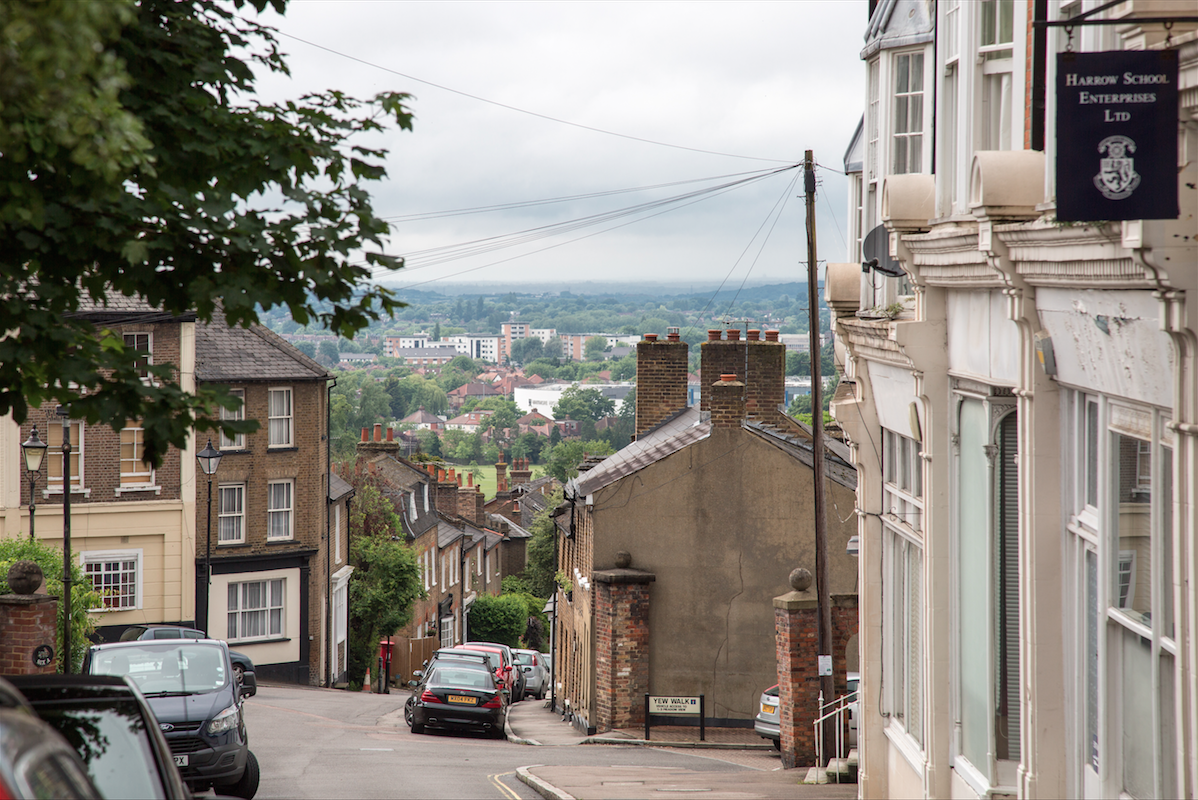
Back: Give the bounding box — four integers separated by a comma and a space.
507, 699, 857, 800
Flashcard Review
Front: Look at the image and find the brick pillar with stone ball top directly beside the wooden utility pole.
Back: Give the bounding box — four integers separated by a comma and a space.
774, 569, 831, 769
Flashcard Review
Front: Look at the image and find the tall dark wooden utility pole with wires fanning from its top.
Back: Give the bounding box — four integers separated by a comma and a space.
803, 150, 840, 766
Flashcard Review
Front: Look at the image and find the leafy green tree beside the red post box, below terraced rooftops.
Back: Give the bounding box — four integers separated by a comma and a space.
349, 473, 425, 685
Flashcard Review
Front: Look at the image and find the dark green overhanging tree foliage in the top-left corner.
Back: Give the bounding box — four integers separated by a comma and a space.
0, 0, 411, 465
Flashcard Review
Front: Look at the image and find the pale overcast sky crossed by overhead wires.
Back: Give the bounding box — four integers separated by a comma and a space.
247, 0, 867, 290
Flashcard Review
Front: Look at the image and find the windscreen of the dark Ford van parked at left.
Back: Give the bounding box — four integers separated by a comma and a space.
91, 640, 229, 695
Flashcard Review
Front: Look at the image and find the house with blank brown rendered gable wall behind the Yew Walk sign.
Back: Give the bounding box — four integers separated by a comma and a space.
555, 331, 857, 729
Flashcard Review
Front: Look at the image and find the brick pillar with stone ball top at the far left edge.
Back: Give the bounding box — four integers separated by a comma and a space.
0, 560, 59, 675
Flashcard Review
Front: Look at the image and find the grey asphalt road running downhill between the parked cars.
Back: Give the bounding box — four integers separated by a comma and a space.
246, 686, 776, 800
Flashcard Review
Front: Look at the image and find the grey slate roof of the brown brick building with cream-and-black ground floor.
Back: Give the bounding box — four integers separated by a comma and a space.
195, 310, 331, 383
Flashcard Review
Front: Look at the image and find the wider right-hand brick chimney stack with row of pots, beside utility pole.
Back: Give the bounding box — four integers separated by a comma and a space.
700, 328, 786, 422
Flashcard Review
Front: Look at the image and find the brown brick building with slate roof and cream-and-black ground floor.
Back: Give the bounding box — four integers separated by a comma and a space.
193, 315, 349, 684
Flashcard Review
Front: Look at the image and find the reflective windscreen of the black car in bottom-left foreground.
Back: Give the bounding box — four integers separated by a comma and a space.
34, 697, 167, 800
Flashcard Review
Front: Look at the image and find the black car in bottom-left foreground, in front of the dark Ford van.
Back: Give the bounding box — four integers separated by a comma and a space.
12, 675, 192, 800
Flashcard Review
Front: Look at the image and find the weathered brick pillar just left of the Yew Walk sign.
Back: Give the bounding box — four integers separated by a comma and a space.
594, 568, 657, 731
